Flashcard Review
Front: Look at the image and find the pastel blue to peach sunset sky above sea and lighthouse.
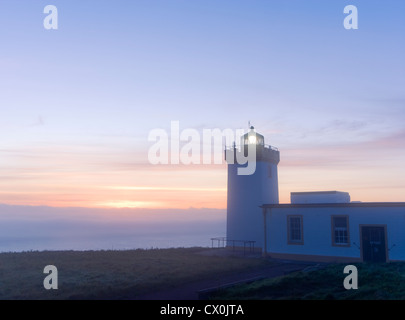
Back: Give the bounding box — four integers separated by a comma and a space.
0, 0, 405, 208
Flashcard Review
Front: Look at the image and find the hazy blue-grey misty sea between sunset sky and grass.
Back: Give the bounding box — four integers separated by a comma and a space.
0, 204, 226, 252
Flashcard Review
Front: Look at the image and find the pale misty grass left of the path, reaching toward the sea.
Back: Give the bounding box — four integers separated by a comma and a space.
0, 248, 268, 299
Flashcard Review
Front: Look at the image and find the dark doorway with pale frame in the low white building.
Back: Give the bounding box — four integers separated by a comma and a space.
360, 225, 388, 262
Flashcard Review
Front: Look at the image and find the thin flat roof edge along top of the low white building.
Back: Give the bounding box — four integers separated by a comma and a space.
260, 202, 405, 209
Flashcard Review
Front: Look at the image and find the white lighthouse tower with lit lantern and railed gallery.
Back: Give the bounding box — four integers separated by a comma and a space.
225, 127, 280, 247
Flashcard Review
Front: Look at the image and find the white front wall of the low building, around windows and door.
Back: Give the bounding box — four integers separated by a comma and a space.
267, 206, 405, 260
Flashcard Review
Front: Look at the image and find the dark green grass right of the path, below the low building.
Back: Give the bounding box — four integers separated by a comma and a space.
212, 263, 405, 300
